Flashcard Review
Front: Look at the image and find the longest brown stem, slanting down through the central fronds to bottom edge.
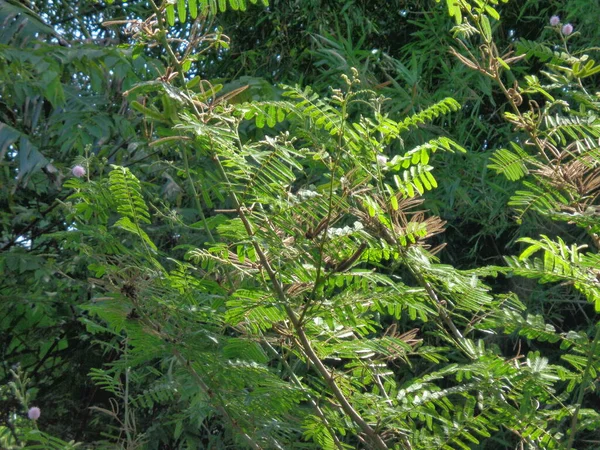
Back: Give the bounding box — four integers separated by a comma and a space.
215, 156, 388, 450
